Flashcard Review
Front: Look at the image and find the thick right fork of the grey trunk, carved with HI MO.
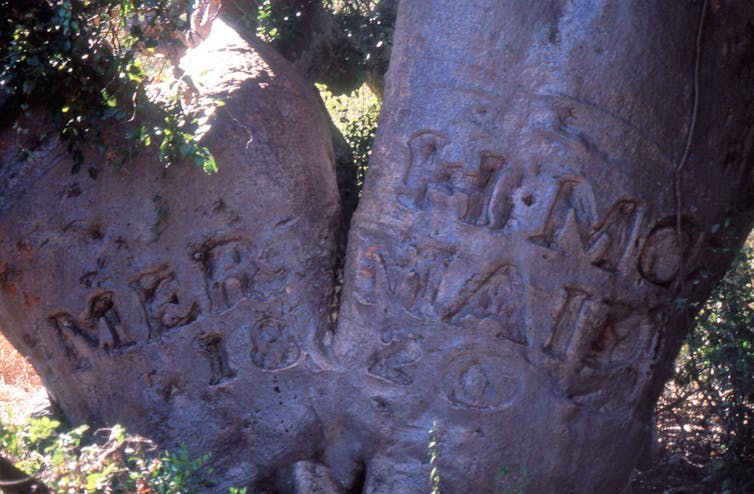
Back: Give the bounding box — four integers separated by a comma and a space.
334, 0, 754, 492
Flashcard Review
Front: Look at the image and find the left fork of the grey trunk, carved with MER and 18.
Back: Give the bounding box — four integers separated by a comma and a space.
0, 18, 339, 492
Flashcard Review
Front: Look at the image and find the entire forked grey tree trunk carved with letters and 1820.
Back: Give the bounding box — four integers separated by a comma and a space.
0, 0, 754, 494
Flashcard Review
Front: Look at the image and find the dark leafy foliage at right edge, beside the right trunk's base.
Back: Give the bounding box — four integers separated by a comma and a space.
675, 237, 754, 492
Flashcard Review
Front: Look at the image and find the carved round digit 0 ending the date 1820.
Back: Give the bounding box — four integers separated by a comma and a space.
443, 351, 520, 410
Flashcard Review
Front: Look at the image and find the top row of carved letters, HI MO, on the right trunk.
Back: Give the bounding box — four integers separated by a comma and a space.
396, 130, 698, 286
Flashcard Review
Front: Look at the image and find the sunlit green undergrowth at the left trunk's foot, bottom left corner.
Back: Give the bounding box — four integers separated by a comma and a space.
0, 417, 246, 494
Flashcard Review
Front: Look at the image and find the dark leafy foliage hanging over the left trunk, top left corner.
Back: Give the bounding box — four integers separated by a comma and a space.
0, 0, 216, 172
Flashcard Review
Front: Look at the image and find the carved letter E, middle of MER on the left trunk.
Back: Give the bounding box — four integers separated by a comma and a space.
131, 266, 199, 338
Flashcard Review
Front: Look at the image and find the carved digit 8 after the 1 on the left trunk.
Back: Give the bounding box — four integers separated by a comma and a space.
250, 317, 301, 371
